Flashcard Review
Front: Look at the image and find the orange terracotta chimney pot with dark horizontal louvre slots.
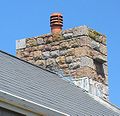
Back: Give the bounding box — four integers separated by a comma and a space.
50, 13, 63, 34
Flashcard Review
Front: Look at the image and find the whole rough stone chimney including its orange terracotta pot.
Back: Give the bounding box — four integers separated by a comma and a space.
16, 13, 108, 100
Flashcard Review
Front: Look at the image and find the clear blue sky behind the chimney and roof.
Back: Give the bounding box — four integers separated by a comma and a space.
0, 0, 120, 107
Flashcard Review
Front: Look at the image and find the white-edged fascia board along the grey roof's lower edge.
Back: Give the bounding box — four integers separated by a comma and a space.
0, 90, 70, 116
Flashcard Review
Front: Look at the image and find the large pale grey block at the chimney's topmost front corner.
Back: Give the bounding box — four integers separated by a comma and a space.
73, 26, 89, 37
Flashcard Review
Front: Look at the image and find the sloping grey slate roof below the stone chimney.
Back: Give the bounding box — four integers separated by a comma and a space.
0, 51, 120, 116
